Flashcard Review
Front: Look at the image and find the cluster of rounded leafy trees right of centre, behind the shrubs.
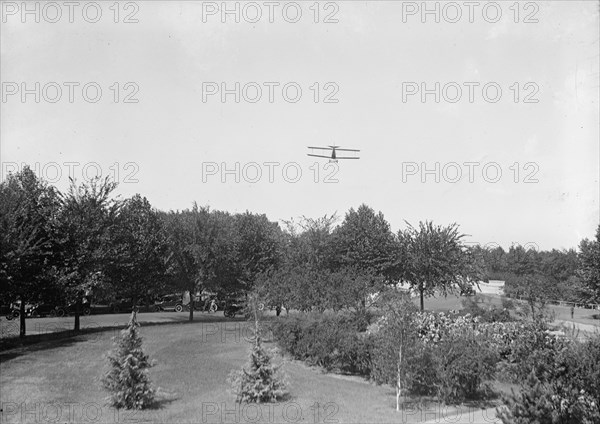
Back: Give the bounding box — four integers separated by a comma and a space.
258, 210, 484, 312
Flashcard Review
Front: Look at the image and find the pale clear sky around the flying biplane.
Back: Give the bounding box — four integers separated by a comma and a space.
0, 0, 600, 249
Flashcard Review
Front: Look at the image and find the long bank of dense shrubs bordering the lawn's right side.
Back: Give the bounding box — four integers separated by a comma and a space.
272, 307, 600, 410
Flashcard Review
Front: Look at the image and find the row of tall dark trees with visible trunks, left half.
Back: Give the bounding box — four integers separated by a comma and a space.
0, 168, 281, 337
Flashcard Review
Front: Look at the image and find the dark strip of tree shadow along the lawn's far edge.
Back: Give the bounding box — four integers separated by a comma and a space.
0, 315, 264, 363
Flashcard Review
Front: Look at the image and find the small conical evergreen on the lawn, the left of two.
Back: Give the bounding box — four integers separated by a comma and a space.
102, 311, 156, 409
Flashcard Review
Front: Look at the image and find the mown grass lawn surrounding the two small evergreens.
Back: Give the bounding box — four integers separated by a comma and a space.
0, 319, 502, 423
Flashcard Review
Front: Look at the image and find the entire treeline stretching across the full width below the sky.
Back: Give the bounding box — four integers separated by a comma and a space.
0, 168, 600, 337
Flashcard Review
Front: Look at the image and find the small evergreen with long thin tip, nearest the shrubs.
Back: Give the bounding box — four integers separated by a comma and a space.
228, 299, 287, 403
